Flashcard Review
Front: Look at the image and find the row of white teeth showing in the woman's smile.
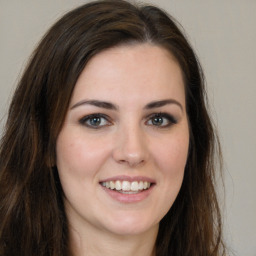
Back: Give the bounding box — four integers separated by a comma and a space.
101, 180, 151, 192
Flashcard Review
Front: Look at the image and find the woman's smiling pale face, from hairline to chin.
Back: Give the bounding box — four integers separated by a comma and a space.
56, 44, 189, 238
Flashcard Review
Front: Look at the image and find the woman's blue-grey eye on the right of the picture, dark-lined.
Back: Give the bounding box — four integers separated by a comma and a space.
147, 113, 177, 128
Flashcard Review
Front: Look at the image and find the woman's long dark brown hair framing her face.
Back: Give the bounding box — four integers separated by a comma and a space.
0, 0, 224, 256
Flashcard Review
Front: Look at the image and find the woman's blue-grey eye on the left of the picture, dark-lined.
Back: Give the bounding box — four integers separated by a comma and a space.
79, 114, 111, 129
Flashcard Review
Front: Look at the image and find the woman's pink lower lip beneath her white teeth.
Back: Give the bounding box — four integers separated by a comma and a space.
102, 185, 154, 203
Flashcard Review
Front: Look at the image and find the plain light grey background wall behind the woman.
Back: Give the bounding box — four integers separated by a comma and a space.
0, 0, 256, 256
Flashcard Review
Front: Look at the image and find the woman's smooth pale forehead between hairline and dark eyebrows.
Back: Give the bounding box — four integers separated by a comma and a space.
71, 43, 184, 107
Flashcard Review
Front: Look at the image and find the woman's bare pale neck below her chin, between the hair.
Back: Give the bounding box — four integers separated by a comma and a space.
70, 222, 158, 256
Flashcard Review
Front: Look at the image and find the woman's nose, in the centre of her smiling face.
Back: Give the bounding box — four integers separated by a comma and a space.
113, 126, 149, 168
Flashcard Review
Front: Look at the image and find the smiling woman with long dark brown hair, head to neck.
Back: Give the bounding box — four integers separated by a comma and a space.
0, 0, 224, 256
